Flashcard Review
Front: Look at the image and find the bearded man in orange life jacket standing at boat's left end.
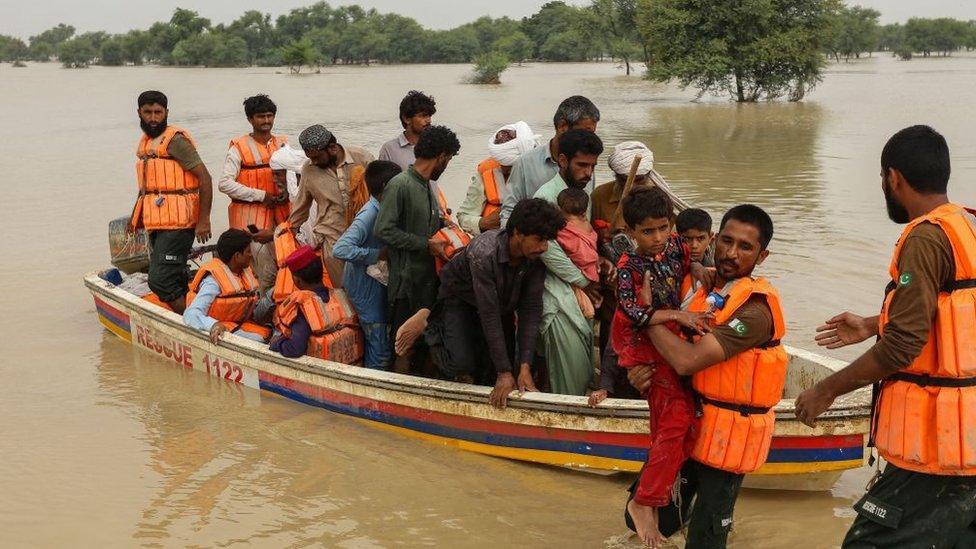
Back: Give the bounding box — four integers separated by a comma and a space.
129, 90, 213, 314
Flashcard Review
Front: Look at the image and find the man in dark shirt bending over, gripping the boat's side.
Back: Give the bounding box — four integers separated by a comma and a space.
396, 198, 566, 408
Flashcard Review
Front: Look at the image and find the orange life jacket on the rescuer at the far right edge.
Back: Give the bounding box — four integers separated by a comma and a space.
874, 204, 976, 476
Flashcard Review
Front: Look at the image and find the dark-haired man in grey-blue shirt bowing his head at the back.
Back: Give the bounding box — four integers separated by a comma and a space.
500, 95, 600, 225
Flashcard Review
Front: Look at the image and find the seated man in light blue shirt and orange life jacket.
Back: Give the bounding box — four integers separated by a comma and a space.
183, 229, 271, 343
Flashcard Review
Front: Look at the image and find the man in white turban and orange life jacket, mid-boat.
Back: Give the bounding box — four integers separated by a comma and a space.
457, 120, 540, 235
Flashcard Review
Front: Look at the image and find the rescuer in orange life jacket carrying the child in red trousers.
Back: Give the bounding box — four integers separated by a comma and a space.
625, 204, 789, 549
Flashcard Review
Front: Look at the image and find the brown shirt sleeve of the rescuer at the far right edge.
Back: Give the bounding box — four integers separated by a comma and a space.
868, 223, 956, 368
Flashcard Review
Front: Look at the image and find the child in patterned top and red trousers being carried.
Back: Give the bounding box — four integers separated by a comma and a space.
610, 187, 709, 543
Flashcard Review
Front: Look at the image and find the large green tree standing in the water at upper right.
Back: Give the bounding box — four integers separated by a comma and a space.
639, 0, 840, 102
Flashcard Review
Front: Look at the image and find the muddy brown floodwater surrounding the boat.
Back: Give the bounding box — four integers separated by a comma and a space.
0, 57, 976, 548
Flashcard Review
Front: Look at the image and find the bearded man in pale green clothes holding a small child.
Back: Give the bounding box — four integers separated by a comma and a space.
535, 129, 603, 395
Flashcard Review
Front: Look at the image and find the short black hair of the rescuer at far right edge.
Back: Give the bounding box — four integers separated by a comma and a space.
881, 125, 951, 194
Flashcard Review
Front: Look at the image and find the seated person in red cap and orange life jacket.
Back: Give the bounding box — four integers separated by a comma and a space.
270, 246, 363, 364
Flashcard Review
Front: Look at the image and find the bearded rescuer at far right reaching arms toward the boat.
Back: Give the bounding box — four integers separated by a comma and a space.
796, 126, 976, 547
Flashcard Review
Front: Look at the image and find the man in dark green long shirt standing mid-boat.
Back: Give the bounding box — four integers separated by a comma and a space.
374, 126, 461, 370
